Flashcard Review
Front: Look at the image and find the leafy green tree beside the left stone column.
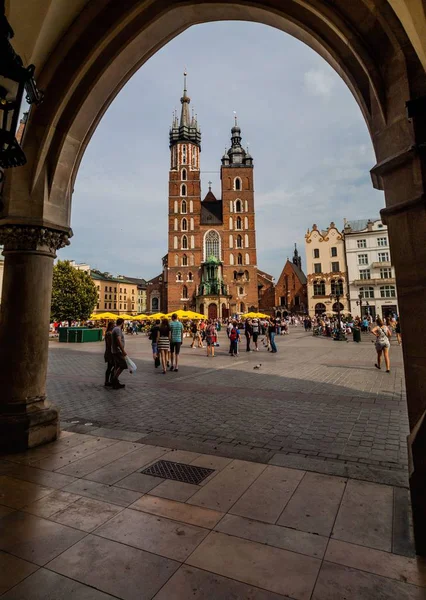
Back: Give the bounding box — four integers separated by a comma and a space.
51, 260, 98, 325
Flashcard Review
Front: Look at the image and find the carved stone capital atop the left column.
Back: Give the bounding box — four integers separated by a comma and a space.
0, 223, 72, 258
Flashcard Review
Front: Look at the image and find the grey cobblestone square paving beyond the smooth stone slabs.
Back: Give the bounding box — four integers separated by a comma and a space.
48, 328, 408, 485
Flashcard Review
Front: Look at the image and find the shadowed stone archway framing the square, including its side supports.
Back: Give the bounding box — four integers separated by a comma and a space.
0, 0, 426, 544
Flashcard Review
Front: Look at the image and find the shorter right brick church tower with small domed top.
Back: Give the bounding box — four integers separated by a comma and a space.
220, 117, 258, 313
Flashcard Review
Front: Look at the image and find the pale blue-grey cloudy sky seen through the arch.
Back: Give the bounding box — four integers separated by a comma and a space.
58, 21, 384, 279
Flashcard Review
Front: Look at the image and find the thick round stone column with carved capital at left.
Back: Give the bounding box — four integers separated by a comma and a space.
0, 224, 70, 452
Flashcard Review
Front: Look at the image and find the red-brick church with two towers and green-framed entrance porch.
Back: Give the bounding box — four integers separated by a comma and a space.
163, 79, 258, 318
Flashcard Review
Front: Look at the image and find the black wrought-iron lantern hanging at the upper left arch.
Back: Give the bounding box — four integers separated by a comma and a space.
0, 14, 43, 169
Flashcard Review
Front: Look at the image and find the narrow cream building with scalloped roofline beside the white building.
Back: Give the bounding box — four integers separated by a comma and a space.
305, 222, 350, 317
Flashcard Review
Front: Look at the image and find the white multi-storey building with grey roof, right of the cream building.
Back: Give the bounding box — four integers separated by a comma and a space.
344, 219, 399, 318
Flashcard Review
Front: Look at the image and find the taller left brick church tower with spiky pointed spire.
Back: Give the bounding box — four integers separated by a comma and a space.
165, 73, 201, 312
